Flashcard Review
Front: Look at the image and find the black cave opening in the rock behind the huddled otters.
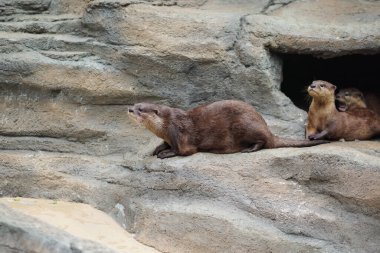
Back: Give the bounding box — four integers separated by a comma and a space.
279, 54, 380, 111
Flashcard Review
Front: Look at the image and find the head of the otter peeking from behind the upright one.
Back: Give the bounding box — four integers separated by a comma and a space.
335, 88, 367, 112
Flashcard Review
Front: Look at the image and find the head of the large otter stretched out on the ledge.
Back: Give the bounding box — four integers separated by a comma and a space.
128, 103, 166, 139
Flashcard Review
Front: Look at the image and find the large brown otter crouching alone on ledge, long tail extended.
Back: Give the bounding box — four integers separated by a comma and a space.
128, 100, 327, 158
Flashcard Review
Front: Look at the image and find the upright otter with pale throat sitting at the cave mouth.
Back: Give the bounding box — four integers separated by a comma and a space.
306, 80, 380, 140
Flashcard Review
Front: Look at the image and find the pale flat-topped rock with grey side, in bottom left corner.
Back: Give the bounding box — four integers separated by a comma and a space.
0, 198, 158, 253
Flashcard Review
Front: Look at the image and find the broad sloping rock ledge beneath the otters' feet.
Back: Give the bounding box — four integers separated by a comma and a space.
0, 142, 380, 252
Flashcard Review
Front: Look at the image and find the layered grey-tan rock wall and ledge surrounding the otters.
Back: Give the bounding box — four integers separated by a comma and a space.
0, 0, 380, 253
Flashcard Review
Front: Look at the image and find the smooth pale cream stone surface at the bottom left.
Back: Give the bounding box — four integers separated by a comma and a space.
0, 198, 158, 253
